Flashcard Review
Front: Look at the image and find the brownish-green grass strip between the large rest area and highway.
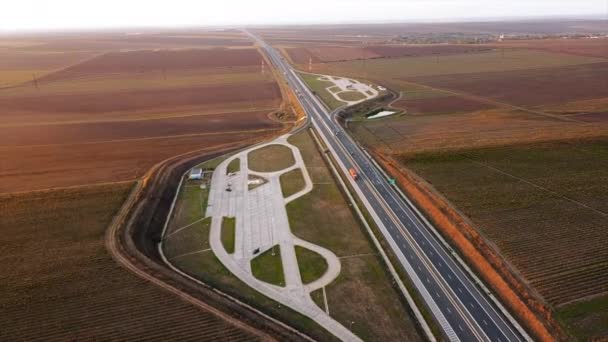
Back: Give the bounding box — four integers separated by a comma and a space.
287, 131, 421, 341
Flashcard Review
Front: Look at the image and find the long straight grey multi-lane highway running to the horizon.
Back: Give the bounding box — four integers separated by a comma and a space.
249, 33, 530, 341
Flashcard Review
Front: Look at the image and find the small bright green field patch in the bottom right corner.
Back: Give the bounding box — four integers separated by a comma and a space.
556, 296, 608, 341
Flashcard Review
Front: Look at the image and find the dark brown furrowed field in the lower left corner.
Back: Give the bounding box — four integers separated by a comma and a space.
0, 182, 257, 341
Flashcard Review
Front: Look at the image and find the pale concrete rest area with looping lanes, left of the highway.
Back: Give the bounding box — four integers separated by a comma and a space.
207, 135, 360, 341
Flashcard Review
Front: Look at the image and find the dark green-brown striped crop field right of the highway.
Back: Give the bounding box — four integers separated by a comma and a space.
402, 137, 608, 333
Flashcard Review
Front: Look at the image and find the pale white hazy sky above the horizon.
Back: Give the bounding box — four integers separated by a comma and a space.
0, 0, 607, 30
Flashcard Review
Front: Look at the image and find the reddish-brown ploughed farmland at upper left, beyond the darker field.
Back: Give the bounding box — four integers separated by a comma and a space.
0, 32, 283, 192
